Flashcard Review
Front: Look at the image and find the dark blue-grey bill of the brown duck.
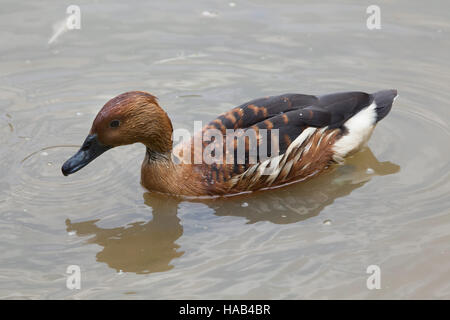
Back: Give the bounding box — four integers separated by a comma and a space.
61, 134, 112, 176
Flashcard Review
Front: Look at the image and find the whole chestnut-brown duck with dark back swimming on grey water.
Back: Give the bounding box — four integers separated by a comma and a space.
62, 89, 397, 197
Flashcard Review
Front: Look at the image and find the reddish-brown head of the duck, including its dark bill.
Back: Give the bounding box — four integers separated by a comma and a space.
62, 91, 172, 176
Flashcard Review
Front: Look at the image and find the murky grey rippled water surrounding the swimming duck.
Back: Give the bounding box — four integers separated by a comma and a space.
0, 0, 450, 299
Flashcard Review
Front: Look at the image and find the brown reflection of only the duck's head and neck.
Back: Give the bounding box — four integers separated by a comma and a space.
66, 193, 183, 273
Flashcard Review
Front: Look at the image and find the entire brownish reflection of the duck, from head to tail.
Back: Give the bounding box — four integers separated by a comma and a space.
66, 149, 400, 273
